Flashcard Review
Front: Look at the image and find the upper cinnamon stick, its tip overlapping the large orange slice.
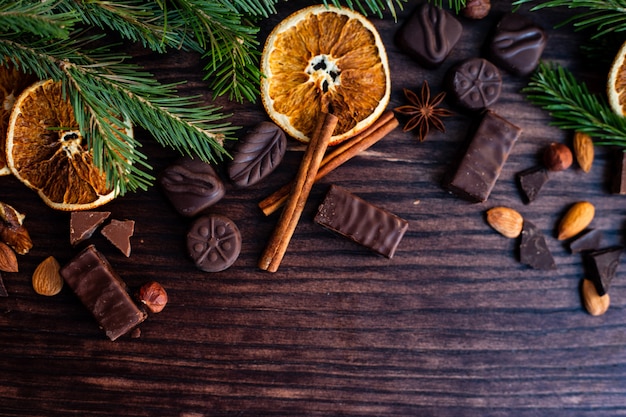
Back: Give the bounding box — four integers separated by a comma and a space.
258, 113, 339, 272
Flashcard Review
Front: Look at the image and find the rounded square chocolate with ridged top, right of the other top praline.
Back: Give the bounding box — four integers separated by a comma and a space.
489, 13, 547, 76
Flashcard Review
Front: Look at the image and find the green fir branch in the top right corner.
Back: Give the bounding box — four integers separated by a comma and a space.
513, 0, 626, 38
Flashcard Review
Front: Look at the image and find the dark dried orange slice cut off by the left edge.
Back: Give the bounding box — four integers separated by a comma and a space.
0, 65, 37, 175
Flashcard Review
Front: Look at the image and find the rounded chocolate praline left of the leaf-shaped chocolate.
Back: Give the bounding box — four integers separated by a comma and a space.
159, 157, 225, 217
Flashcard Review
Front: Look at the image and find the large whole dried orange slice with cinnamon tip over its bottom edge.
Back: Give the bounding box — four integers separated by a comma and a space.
261, 5, 391, 145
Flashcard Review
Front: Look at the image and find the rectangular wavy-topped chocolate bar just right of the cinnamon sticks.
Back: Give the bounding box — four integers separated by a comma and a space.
314, 185, 409, 258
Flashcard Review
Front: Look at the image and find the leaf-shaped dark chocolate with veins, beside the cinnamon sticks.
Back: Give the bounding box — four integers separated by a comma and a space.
228, 122, 287, 188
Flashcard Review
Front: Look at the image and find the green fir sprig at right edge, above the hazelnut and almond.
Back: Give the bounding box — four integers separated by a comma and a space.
522, 63, 626, 148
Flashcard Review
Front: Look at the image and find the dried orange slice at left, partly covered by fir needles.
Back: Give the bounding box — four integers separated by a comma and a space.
6, 80, 127, 211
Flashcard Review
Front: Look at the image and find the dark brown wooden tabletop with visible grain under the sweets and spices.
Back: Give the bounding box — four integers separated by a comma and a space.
0, 2, 626, 417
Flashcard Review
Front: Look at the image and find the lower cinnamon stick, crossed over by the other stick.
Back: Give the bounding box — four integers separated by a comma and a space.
259, 111, 398, 216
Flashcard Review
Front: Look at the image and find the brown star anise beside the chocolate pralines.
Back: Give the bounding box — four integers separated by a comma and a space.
394, 80, 454, 142
